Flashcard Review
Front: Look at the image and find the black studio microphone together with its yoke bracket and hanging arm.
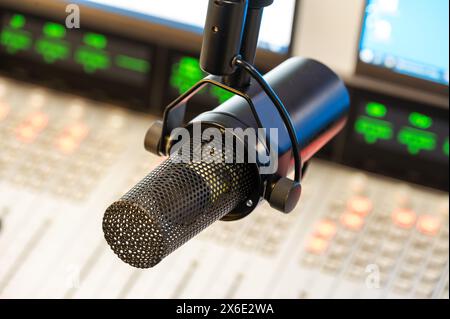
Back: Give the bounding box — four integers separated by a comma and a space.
103, 0, 350, 268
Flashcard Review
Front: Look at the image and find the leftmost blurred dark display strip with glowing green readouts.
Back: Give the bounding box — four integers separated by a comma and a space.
0, 13, 152, 85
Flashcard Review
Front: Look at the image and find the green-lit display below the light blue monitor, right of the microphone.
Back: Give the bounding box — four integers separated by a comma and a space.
354, 101, 449, 161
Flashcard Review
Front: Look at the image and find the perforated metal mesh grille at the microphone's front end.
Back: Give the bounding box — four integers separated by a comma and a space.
103, 144, 258, 268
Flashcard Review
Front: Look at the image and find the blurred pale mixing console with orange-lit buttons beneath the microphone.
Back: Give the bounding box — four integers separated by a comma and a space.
0, 78, 449, 298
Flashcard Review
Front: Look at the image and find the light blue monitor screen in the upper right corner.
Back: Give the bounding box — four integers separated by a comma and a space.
359, 0, 449, 86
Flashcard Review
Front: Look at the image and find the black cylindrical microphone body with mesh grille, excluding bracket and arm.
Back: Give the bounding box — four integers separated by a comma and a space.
103, 58, 350, 268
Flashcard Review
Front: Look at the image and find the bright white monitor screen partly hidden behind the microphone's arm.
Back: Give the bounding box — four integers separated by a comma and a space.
75, 0, 296, 54
